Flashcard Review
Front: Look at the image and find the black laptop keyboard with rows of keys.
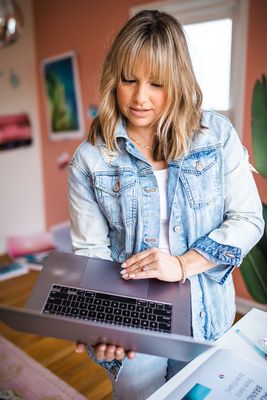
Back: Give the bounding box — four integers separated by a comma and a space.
43, 284, 172, 333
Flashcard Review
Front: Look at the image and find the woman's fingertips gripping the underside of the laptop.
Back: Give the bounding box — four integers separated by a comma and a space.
76, 343, 135, 361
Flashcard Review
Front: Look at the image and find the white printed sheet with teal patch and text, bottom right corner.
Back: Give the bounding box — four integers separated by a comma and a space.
167, 349, 267, 400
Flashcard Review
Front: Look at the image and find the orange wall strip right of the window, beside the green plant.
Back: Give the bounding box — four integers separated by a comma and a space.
234, 0, 267, 300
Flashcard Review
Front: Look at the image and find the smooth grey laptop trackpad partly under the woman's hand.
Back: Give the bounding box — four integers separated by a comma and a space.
80, 258, 149, 299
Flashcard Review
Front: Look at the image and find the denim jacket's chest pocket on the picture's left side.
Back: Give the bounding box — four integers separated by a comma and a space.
94, 171, 136, 225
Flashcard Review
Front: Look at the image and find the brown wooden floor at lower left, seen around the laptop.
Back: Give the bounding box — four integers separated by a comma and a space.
0, 271, 112, 400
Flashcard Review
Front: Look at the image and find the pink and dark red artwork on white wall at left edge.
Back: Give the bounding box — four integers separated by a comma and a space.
0, 113, 32, 151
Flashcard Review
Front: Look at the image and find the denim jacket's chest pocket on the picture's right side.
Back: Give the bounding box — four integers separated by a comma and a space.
181, 150, 222, 208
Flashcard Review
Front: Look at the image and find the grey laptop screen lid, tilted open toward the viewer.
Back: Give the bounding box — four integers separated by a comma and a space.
0, 305, 212, 361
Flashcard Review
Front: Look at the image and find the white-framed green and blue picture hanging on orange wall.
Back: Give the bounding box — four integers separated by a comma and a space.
42, 52, 84, 140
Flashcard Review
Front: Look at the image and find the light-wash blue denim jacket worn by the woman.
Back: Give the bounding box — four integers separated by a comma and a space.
69, 111, 264, 378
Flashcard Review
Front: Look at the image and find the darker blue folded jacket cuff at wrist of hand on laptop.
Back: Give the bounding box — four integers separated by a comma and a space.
191, 236, 241, 285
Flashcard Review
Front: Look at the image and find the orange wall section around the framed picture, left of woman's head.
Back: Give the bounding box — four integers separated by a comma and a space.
34, 0, 148, 227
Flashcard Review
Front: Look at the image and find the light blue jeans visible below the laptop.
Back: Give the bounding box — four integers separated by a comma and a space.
107, 353, 186, 400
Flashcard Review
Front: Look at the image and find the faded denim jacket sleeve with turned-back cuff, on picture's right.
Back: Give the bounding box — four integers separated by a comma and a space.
191, 125, 264, 284
